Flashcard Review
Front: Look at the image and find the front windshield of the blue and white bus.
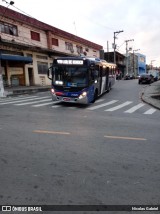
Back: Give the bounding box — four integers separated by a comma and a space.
52, 66, 88, 87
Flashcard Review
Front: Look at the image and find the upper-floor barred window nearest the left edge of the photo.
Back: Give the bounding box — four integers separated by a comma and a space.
0, 22, 18, 36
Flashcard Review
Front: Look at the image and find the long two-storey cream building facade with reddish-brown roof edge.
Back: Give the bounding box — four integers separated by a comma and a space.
0, 6, 103, 86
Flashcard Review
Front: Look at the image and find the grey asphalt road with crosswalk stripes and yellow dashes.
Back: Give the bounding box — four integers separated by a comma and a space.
0, 80, 160, 213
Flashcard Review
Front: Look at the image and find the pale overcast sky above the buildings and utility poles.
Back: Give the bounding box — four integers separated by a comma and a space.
0, 0, 160, 66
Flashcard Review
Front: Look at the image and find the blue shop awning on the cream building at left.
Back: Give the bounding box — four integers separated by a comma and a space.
0, 54, 33, 63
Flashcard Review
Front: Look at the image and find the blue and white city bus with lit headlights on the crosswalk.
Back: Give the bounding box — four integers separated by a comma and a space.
48, 56, 116, 104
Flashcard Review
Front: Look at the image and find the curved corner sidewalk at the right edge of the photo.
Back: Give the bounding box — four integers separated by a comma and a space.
141, 80, 160, 110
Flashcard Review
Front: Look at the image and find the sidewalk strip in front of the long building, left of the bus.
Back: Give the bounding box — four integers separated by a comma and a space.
4, 86, 51, 96
